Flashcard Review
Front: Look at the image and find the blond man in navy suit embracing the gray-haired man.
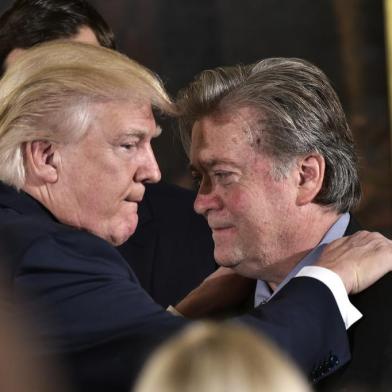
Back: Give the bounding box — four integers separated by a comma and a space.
0, 42, 391, 391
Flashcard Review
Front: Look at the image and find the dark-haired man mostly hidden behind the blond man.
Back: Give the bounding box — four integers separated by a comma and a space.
0, 0, 217, 307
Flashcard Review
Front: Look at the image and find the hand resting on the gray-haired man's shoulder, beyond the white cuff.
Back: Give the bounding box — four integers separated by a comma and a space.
317, 231, 392, 294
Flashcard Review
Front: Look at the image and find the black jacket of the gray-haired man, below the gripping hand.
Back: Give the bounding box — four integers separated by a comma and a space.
317, 218, 392, 392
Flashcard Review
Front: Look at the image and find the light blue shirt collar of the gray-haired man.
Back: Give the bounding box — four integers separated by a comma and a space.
254, 212, 350, 306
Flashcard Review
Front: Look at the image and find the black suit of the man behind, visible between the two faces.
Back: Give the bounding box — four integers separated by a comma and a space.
118, 182, 216, 308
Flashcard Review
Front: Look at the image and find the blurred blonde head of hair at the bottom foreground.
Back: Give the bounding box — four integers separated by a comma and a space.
134, 323, 311, 392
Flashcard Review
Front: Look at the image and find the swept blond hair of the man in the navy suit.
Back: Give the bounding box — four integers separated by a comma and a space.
0, 41, 175, 188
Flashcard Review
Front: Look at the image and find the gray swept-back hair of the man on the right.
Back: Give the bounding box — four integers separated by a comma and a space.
177, 58, 361, 212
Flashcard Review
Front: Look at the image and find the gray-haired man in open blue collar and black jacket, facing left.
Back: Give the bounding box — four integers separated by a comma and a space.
178, 58, 392, 391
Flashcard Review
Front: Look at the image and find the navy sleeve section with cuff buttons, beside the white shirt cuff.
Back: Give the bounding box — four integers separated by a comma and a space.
238, 277, 350, 382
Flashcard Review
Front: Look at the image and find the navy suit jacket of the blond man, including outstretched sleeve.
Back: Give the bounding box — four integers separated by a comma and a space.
0, 183, 349, 392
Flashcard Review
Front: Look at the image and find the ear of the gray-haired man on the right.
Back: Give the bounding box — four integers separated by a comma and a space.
296, 154, 325, 206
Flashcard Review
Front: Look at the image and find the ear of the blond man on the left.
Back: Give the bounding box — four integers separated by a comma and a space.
25, 140, 58, 183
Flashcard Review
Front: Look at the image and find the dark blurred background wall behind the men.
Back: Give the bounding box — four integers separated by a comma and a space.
0, 0, 392, 236
